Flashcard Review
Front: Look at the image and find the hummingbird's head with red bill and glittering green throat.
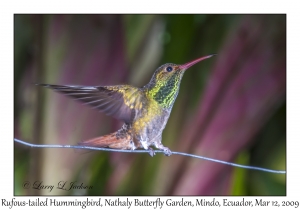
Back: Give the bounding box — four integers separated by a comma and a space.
144, 54, 216, 108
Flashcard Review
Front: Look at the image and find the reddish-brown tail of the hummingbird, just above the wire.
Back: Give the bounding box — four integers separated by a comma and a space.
78, 132, 133, 149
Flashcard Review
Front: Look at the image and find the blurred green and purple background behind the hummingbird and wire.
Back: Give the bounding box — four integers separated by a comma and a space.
14, 15, 286, 195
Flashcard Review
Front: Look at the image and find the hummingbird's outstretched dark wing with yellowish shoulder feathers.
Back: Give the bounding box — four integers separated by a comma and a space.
36, 84, 142, 122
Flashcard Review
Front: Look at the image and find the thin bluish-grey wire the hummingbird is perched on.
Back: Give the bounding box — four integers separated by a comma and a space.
14, 138, 286, 174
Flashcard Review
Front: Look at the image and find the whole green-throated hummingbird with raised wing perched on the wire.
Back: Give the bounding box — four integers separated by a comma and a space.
37, 54, 215, 156
